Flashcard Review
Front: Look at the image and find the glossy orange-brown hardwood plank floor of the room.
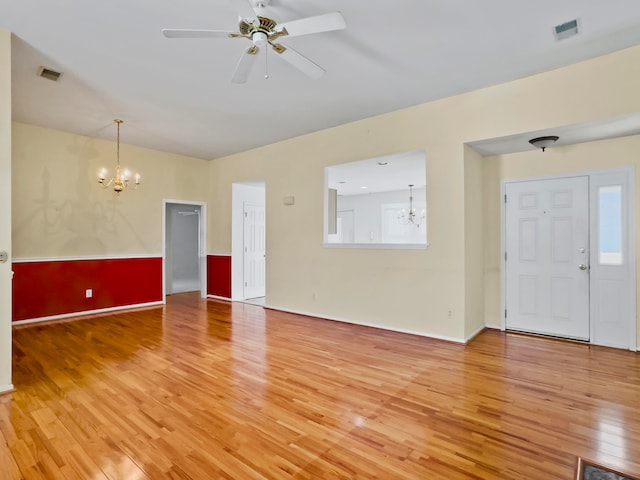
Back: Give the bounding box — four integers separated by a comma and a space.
0, 294, 640, 480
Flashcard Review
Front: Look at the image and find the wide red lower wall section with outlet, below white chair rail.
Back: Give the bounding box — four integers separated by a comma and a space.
12, 257, 162, 321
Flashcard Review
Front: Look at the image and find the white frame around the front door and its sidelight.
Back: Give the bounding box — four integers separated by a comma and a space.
500, 166, 637, 351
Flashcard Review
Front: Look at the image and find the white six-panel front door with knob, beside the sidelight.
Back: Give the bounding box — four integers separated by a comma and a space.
505, 176, 590, 340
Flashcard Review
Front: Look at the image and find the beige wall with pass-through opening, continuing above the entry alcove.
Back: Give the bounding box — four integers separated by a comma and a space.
209, 47, 640, 339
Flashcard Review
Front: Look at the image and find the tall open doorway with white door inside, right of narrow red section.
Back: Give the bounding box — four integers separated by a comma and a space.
231, 180, 266, 305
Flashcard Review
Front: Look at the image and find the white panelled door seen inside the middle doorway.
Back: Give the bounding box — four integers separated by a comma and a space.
243, 203, 266, 299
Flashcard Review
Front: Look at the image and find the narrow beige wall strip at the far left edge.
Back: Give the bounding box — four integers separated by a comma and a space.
0, 29, 11, 392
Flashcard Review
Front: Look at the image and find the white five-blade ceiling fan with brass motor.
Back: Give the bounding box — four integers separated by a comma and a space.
162, 0, 346, 83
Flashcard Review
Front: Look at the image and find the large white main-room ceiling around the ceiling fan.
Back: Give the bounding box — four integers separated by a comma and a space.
0, 0, 640, 159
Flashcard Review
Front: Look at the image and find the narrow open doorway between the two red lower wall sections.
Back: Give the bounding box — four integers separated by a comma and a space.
163, 200, 206, 298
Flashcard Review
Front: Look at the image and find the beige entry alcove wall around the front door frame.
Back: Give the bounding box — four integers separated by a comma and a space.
484, 135, 640, 345
